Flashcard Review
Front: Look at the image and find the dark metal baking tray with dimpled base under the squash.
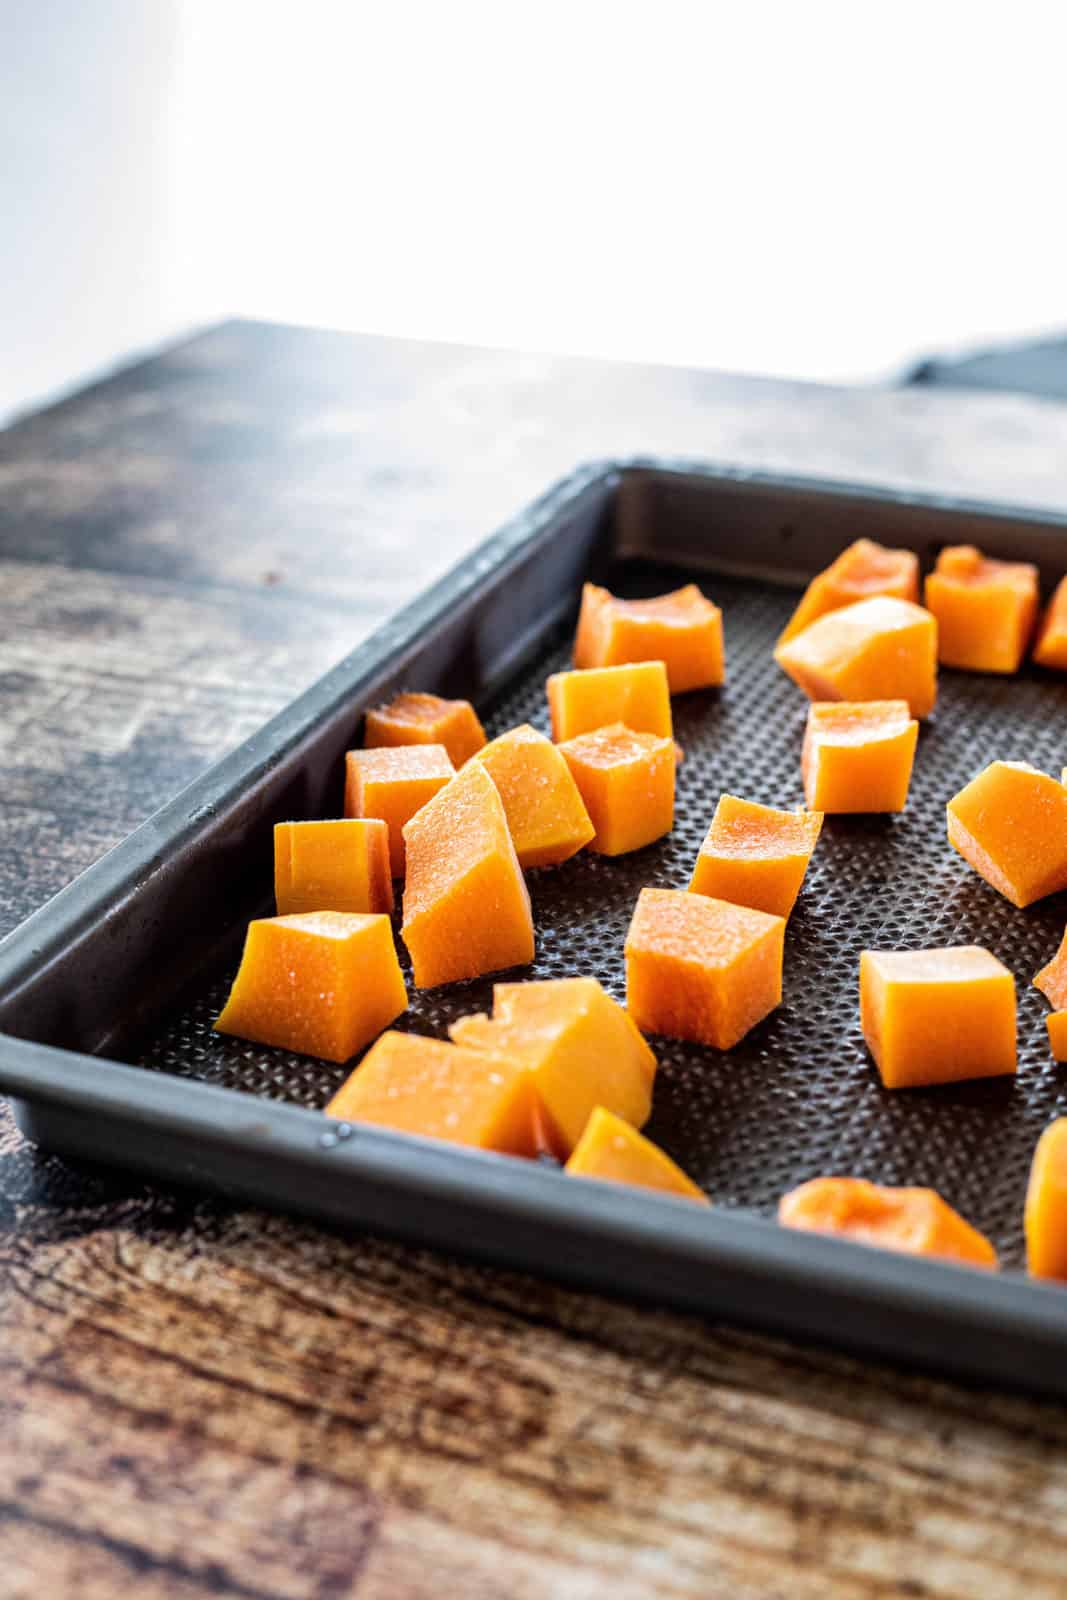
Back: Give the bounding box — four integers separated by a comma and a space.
0, 462, 1067, 1395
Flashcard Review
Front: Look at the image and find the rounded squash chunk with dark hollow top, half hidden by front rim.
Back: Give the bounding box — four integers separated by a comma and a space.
777, 1178, 997, 1267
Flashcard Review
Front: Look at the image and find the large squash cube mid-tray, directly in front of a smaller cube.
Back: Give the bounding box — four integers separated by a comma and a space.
625, 890, 785, 1050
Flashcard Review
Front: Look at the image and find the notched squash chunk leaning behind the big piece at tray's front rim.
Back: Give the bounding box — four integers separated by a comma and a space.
448, 978, 656, 1158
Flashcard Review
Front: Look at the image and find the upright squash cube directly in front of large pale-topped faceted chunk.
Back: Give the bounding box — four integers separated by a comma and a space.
800, 701, 918, 813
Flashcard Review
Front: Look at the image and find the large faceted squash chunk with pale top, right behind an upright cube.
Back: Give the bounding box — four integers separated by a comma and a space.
774, 595, 937, 717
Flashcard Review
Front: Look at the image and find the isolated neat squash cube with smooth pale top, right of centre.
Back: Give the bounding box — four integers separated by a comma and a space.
859, 944, 1016, 1090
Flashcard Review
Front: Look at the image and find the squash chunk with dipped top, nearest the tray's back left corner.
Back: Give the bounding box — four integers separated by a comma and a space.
574, 584, 725, 694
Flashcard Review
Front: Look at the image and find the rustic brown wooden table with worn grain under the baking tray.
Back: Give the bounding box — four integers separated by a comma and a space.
0, 323, 1067, 1600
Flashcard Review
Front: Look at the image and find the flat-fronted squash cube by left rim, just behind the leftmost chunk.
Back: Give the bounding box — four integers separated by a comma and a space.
274, 818, 392, 917
